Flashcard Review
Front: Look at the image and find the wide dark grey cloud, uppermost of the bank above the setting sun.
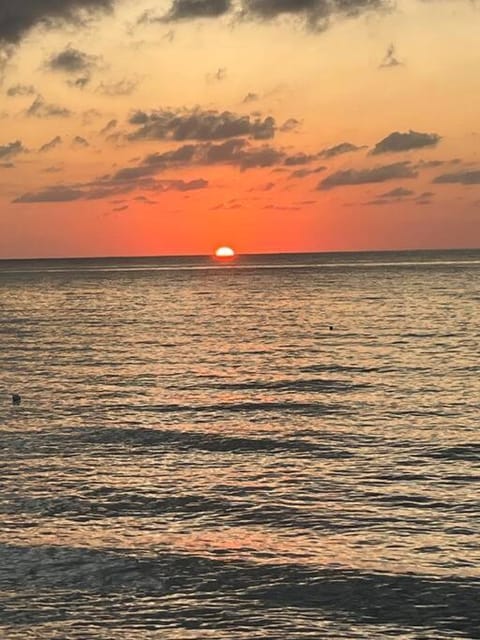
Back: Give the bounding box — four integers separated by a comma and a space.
128, 109, 275, 141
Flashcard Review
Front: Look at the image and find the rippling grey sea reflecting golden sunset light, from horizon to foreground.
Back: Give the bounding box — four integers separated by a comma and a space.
0, 251, 480, 640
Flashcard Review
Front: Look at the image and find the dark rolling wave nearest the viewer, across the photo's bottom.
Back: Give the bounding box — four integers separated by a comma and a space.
0, 545, 480, 639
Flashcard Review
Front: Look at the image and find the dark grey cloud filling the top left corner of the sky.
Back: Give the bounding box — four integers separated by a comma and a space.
0, 0, 114, 48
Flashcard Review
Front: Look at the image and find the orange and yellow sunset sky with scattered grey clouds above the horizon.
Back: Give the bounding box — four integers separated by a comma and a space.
0, 0, 480, 258
